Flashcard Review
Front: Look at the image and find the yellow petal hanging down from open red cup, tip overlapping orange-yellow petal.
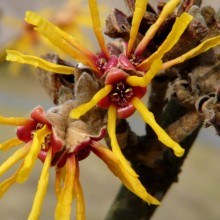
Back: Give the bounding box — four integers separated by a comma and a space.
107, 105, 137, 177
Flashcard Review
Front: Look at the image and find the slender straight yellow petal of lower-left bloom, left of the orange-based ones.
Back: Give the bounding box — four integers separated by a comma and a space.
28, 148, 52, 220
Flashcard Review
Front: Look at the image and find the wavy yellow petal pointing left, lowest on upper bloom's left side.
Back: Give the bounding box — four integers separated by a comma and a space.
6, 50, 74, 74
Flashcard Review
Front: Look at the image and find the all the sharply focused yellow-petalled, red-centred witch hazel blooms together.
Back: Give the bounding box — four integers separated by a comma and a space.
0, 0, 220, 219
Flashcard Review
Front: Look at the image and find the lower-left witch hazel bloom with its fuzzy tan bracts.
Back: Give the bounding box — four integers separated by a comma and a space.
0, 73, 159, 220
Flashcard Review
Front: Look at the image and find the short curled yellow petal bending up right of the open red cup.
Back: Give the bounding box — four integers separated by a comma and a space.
126, 60, 162, 87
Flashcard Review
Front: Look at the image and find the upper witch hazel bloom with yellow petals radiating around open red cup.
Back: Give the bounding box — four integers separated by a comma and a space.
7, 0, 220, 207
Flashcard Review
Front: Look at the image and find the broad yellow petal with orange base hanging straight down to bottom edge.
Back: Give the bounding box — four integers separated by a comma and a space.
55, 156, 76, 220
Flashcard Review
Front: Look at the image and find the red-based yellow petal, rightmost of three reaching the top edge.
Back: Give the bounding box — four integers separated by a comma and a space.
135, 0, 180, 55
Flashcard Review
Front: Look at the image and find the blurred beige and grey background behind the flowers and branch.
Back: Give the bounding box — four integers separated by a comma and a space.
0, 0, 220, 220
